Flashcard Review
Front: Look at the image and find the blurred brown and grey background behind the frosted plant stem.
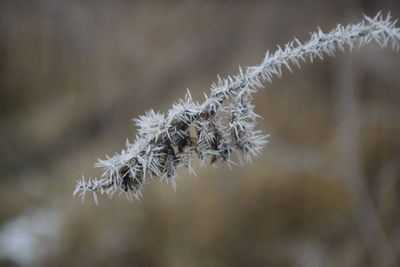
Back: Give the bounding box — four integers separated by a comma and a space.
0, 0, 400, 267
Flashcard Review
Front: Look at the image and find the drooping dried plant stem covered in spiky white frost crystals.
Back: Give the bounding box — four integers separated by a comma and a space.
74, 13, 400, 203
